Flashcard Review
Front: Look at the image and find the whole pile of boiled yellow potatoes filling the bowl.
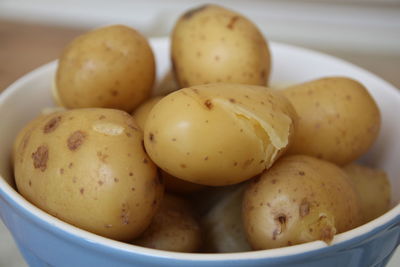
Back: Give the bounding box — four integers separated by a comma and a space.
13, 5, 390, 255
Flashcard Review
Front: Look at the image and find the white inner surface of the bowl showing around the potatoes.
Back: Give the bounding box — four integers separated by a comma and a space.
0, 38, 400, 260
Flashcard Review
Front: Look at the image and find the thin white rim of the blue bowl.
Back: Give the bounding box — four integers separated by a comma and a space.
0, 38, 400, 261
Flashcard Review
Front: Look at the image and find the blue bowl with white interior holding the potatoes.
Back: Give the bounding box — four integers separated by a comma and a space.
0, 38, 400, 267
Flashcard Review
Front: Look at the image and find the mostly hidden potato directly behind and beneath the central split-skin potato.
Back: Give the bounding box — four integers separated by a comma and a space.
132, 96, 204, 194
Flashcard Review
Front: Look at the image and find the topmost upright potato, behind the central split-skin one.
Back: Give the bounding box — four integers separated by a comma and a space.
171, 5, 271, 88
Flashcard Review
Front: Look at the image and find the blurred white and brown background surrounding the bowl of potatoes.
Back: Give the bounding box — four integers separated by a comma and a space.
0, 0, 400, 267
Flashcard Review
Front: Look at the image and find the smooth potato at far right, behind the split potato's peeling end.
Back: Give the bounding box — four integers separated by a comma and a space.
283, 77, 381, 165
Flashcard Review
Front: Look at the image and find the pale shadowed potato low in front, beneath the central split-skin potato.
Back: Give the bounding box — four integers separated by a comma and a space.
201, 184, 251, 253
